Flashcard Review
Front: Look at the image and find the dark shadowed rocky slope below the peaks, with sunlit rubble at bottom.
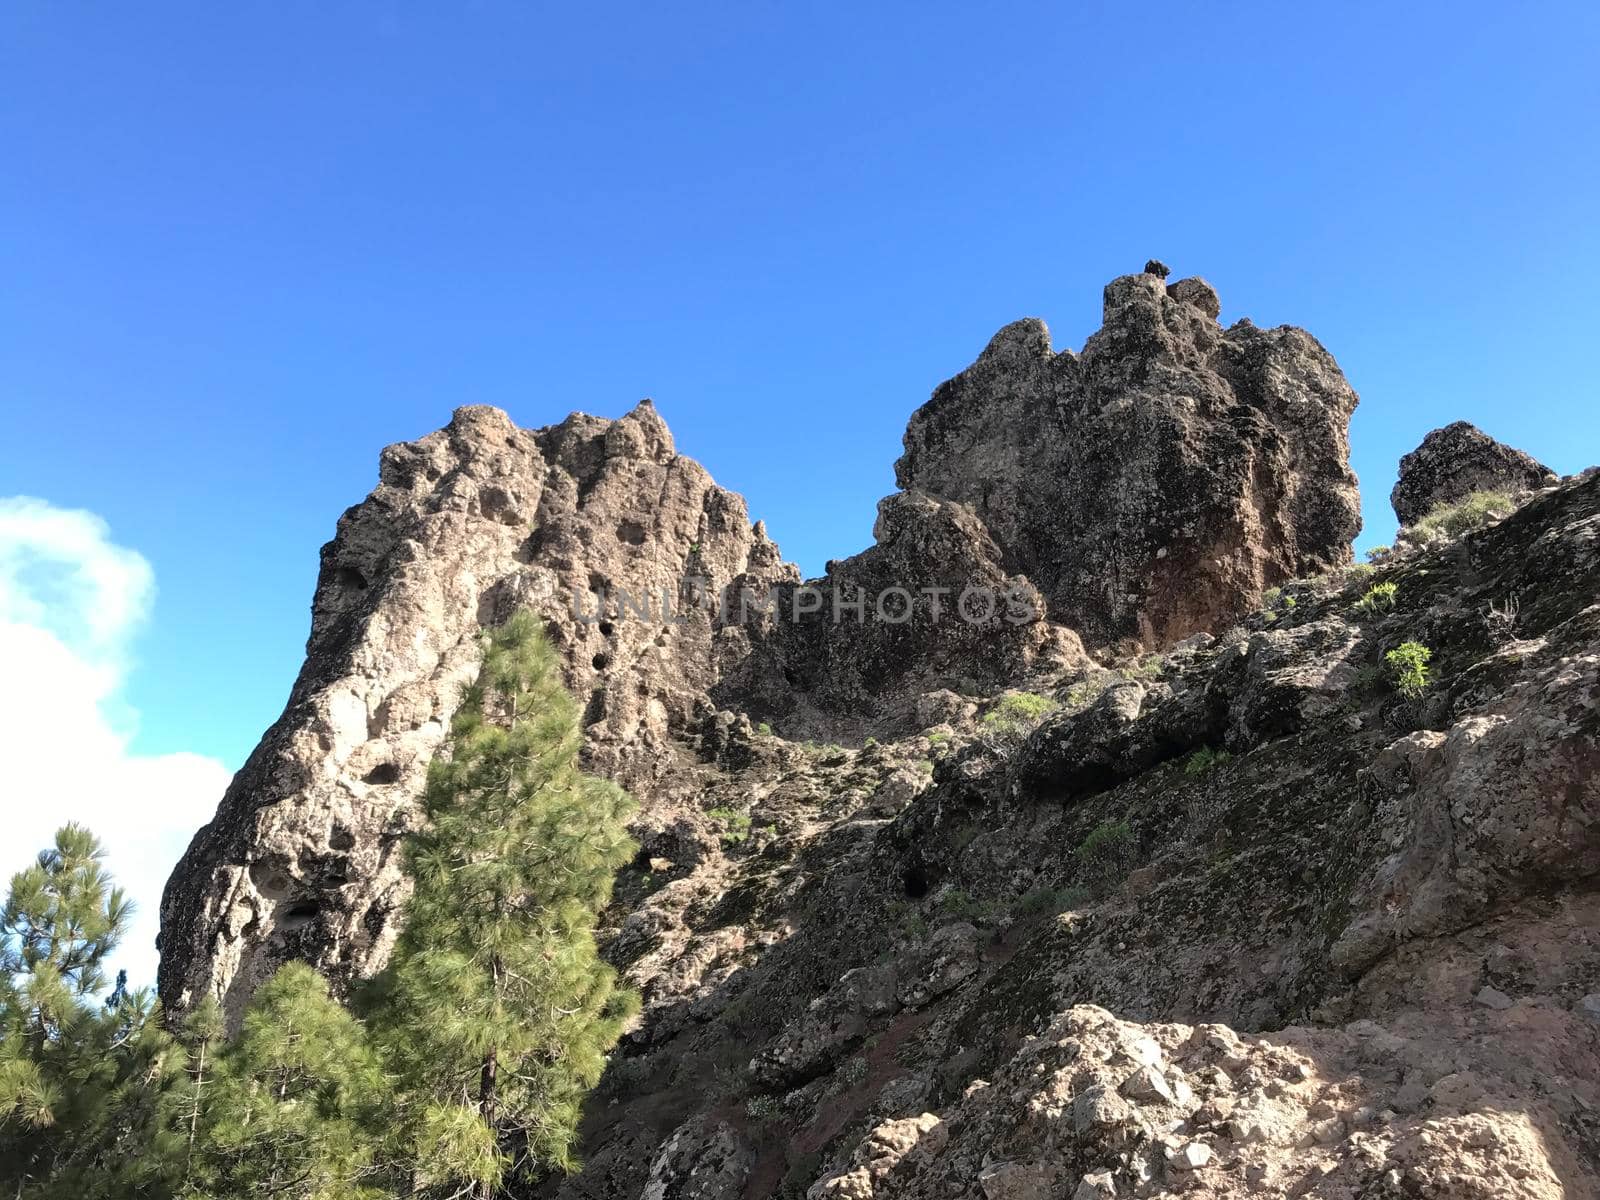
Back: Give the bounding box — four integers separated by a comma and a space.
550, 477, 1600, 1200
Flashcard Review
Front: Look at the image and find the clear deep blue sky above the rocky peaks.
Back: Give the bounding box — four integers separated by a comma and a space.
0, 0, 1600, 966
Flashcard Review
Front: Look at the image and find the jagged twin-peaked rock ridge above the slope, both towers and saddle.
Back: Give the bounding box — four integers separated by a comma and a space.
160, 267, 1355, 1011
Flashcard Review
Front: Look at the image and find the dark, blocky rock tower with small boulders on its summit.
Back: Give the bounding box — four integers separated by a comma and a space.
894, 270, 1360, 646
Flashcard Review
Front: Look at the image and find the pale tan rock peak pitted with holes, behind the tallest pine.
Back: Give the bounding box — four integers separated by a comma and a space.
160, 402, 795, 1014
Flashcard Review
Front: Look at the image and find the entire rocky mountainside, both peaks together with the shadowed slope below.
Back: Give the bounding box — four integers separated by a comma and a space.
162, 272, 1600, 1200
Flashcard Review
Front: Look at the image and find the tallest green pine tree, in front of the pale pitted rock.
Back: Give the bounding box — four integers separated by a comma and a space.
374, 613, 637, 1197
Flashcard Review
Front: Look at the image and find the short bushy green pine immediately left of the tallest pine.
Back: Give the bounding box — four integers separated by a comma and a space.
182, 963, 392, 1200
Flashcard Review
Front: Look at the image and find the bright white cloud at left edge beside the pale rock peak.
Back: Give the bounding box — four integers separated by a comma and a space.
0, 496, 229, 986
